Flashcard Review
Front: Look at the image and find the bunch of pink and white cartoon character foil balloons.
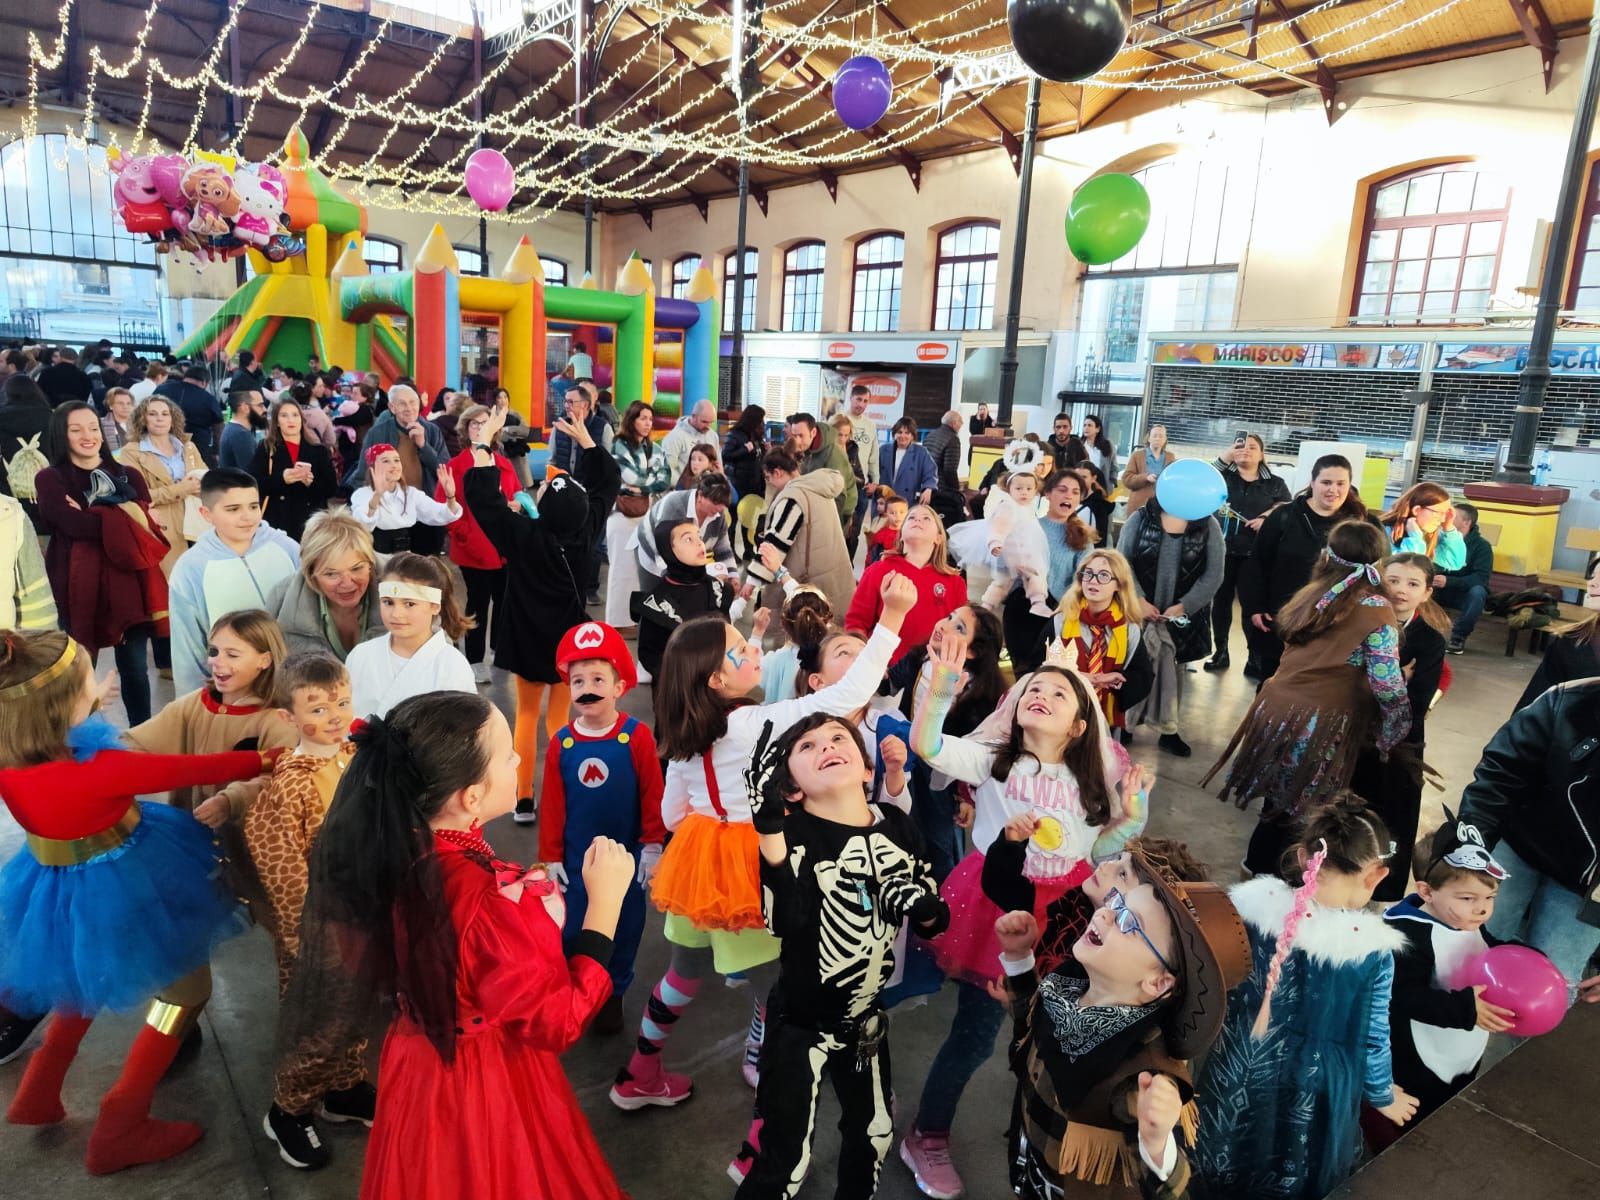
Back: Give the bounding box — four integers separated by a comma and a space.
106, 150, 306, 262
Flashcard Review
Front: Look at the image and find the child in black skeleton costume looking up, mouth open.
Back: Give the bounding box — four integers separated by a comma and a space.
736, 714, 950, 1200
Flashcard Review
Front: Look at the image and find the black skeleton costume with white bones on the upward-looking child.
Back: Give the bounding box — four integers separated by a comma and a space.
738, 805, 949, 1200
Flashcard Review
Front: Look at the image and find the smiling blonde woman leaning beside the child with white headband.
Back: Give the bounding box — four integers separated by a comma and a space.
267, 512, 387, 662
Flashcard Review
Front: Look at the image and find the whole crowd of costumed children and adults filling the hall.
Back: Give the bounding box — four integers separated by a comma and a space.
0, 347, 1600, 1200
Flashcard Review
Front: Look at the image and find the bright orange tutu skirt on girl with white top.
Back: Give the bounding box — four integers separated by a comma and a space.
650, 813, 766, 931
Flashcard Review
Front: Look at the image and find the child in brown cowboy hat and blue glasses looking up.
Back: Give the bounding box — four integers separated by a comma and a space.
995, 851, 1250, 1200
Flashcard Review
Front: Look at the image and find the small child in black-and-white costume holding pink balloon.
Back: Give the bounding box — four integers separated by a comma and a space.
1362, 808, 1517, 1150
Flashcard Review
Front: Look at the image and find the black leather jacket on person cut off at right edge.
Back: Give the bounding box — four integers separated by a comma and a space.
1459, 678, 1600, 896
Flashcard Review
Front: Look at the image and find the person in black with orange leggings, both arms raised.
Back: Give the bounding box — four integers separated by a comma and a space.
466, 408, 622, 824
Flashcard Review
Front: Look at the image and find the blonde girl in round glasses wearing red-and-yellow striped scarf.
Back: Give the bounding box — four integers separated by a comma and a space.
1056, 549, 1152, 746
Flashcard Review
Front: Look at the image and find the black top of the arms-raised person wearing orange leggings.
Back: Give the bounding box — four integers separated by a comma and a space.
462, 445, 622, 683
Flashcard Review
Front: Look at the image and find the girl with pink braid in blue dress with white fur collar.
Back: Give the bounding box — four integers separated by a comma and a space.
1194, 792, 1416, 1200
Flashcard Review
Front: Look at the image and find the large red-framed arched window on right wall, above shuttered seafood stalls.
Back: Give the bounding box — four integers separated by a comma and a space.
1350, 163, 1509, 323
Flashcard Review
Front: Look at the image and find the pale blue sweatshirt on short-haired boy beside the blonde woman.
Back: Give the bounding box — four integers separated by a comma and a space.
166, 522, 299, 696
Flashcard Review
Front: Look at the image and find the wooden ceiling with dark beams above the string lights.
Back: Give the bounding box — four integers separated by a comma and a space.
0, 0, 1592, 220
